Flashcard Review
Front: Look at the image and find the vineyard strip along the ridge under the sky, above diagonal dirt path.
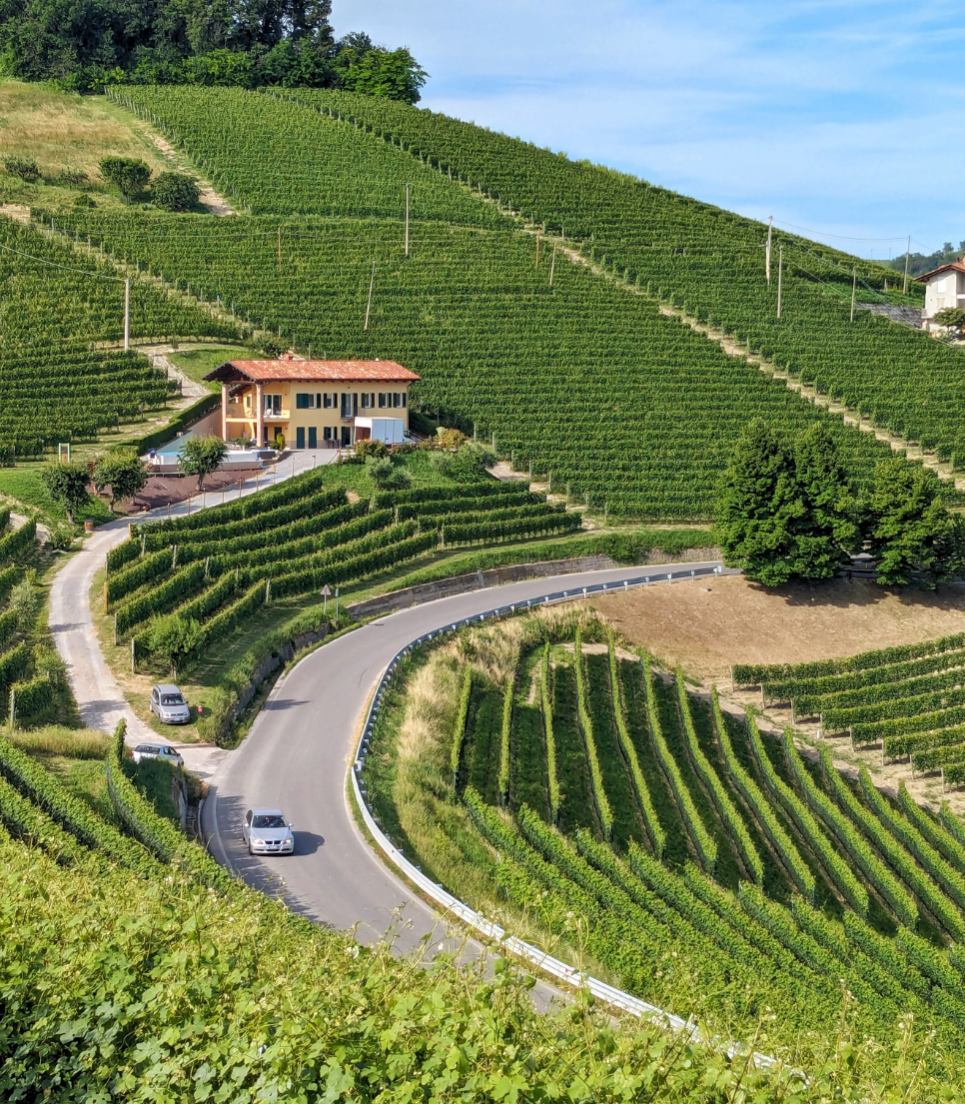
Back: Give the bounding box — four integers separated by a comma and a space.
280, 89, 965, 466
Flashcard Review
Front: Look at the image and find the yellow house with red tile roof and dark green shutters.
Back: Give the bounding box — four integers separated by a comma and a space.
204, 352, 420, 448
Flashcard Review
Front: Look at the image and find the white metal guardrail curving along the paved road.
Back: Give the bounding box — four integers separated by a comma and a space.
351, 564, 776, 1066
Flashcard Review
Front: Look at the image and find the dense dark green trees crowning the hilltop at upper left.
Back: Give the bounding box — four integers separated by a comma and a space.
0, 0, 426, 97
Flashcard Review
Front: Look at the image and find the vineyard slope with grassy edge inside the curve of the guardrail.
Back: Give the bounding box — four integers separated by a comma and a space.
367, 615, 965, 1053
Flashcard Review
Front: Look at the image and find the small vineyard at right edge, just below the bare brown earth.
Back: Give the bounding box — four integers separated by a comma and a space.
734, 634, 965, 794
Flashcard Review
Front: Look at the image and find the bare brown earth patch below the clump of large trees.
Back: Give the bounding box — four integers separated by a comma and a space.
594, 575, 965, 689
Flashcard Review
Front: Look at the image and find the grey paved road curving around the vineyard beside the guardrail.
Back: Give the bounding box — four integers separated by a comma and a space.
202, 562, 728, 951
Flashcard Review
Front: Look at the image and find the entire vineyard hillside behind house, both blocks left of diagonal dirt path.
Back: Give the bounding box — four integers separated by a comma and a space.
41, 88, 923, 520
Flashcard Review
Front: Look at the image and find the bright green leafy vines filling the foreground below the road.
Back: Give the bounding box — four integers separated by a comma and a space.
0, 731, 958, 1104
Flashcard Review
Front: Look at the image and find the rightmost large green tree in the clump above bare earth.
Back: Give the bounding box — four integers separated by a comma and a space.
866, 457, 963, 588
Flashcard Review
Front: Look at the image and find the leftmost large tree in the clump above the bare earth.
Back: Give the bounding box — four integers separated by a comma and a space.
715, 418, 805, 586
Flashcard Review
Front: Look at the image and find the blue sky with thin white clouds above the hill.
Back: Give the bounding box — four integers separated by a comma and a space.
332, 0, 965, 258
